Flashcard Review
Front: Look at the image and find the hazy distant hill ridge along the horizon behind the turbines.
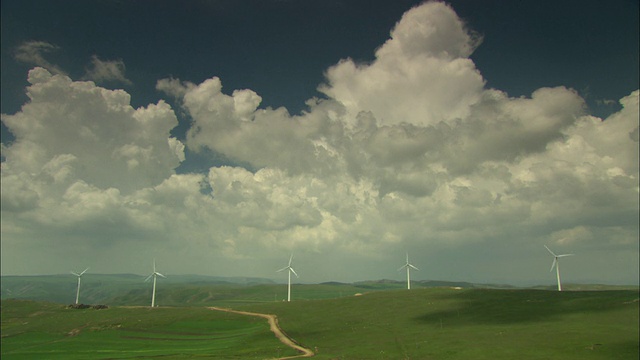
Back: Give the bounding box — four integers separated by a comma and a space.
0, 273, 638, 306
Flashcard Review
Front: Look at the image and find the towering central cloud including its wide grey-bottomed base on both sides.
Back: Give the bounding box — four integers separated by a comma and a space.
184, 3, 585, 177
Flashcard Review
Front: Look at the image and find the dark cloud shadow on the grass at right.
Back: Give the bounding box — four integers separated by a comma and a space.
416, 289, 638, 325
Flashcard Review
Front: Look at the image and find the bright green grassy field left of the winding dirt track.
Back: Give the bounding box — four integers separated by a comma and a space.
1, 300, 296, 359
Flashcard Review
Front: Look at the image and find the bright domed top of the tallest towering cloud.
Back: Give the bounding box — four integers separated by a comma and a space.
319, 2, 484, 125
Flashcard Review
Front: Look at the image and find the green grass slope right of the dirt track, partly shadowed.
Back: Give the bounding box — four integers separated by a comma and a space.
245, 289, 639, 359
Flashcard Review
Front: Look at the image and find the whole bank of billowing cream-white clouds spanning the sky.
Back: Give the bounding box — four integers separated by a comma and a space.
2, 2, 639, 280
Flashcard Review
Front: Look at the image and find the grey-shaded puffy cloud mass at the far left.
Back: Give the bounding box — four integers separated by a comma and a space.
2, 68, 184, 198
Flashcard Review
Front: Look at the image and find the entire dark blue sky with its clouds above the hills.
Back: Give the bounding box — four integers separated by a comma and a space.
0, 0, 640, 286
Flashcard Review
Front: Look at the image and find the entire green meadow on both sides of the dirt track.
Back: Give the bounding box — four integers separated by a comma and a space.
2, 284, 640, 359
